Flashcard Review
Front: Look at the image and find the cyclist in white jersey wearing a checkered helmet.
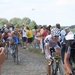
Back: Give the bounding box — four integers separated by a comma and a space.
44, 27, 60, 75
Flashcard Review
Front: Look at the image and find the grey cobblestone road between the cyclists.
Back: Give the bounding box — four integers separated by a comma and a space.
2, 48, 46, 75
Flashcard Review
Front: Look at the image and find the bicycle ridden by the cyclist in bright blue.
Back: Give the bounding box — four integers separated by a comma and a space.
10, 44, 19, 65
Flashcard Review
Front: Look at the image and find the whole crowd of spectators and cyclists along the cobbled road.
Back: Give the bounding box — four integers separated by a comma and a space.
0, 24, 74, 75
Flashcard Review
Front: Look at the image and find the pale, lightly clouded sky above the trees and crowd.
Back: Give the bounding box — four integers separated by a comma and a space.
0, 0, 75, 26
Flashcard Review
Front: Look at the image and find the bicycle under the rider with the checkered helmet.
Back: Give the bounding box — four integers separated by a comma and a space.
49, 48, 64, 75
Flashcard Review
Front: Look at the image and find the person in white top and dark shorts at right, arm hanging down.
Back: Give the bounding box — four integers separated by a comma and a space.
61, 27, 74, 75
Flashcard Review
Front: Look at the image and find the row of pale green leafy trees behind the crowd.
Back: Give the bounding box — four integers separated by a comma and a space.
0, 17, 37, 29
